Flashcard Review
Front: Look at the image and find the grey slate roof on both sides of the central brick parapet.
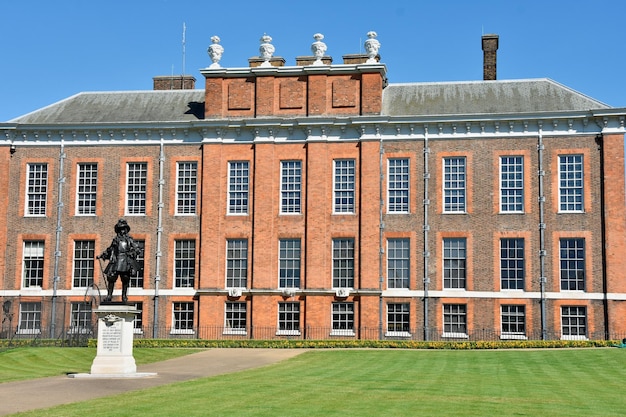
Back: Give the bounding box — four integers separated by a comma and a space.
10, 79, 610, 124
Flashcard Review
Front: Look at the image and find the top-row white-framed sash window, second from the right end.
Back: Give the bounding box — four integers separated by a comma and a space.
500, 155, 525, 214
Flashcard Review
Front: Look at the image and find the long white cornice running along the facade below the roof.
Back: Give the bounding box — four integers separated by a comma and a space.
0, 111, 626, 146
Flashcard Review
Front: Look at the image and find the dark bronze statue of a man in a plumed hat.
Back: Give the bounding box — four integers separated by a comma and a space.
97, 219, 141, 303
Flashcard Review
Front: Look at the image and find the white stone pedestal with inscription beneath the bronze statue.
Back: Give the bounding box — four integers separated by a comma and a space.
91, 303, 139, 375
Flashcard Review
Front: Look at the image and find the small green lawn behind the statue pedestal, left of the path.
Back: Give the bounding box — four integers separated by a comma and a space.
0, 347, 199, 382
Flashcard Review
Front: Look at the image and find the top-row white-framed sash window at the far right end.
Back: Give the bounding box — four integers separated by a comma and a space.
559, 154, 585, 213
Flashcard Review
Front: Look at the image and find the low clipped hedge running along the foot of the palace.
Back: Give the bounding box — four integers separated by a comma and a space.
0, 339, 620, 350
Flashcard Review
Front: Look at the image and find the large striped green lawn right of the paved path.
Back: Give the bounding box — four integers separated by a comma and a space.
8, 349, 626, 417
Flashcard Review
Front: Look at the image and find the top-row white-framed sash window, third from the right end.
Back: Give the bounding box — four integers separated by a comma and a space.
442, 156, 467, 214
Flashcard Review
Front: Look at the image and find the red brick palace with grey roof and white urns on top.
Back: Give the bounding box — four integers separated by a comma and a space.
0, 34, 626, 340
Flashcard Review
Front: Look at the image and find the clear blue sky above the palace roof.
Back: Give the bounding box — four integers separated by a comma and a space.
0, 0, 626, 121
